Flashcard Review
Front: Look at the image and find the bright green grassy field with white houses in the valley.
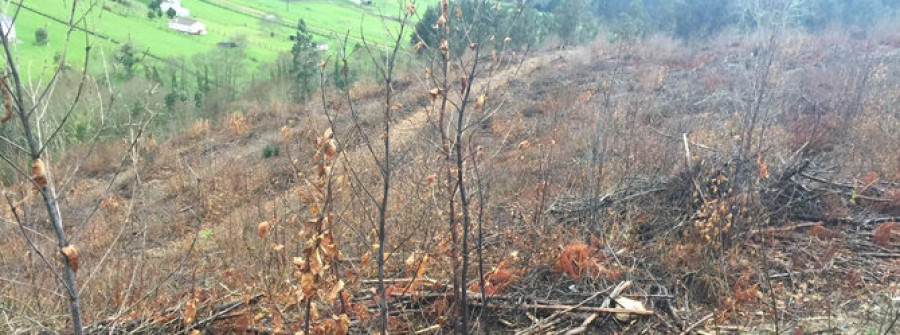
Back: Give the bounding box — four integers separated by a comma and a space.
7, 0, 423, 76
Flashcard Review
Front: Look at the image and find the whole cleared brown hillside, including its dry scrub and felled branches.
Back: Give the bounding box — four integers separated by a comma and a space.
0, 24, 900, 334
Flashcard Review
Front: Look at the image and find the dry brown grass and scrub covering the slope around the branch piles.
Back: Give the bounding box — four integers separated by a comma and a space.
0, 28, 900, 332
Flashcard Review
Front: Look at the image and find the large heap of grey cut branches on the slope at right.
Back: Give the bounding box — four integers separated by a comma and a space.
548, 157, 900, 239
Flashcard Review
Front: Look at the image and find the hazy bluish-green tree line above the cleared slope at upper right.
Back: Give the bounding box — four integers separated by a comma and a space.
478, 0, 900, 42
